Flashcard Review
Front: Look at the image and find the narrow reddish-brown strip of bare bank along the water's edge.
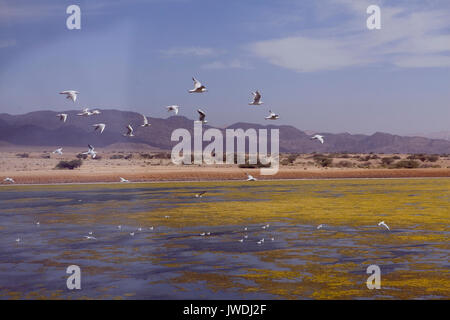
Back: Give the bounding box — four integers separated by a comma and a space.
0, 166, 450, 184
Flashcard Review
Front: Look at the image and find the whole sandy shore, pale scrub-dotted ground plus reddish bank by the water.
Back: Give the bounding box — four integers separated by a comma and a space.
0, 147, 450, 184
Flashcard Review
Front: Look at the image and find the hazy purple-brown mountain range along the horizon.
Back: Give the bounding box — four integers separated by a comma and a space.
0, 110, 450, 154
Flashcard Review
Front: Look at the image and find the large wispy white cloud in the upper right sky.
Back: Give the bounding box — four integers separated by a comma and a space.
248, 0, 450, 72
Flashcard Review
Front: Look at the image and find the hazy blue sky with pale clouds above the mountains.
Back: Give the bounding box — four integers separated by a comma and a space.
0, 0, 450, 134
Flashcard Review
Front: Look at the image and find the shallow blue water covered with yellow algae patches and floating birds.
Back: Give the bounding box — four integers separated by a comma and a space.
0, 179, 450, 299
